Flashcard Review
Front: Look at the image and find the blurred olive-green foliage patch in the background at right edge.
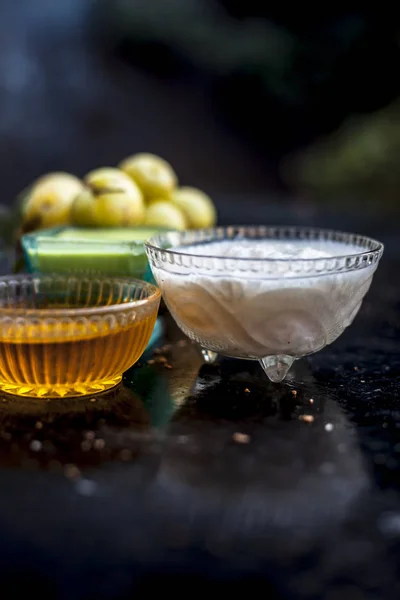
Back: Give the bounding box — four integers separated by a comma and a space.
282, 99, 400, 205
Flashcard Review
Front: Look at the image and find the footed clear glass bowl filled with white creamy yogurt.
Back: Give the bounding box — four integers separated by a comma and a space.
146, 226, 383, 382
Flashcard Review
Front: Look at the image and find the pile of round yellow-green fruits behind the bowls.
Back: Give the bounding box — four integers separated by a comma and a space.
20, 153, 216, 233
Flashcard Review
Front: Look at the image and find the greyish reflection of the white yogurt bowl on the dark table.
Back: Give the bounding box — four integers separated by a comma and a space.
149, 380, 369, 558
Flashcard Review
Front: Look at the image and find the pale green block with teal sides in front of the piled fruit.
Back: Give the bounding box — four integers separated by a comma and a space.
22, 227, 164, 279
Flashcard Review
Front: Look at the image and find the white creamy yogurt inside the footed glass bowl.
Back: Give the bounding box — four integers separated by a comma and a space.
153, 240, 376, 359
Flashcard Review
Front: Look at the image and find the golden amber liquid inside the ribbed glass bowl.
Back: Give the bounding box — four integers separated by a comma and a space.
0, 314, 156, 396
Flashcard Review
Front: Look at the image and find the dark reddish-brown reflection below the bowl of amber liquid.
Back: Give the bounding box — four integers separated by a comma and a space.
0, 384, 158, 479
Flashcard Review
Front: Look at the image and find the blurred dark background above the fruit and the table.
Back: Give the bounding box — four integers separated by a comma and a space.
0, 0, 400, 212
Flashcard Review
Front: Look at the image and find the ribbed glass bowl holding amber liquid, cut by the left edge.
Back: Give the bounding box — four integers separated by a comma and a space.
0, 275, 161, 397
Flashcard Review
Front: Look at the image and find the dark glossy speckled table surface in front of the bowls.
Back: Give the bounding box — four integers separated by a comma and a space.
0, 211, 400, 600
